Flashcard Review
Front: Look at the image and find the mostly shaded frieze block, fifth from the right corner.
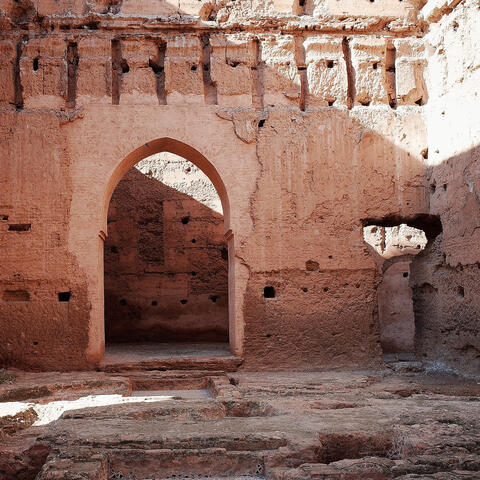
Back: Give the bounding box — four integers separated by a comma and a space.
210, 35, 256, 107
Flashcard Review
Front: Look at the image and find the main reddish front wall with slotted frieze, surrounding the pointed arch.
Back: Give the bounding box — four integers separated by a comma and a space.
0, 0, 429, 369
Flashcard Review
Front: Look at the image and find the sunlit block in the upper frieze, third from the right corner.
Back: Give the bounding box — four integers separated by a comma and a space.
305, 37, 348, 107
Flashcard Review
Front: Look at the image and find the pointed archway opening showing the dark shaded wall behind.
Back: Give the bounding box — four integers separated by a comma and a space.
104, 151, 229, 355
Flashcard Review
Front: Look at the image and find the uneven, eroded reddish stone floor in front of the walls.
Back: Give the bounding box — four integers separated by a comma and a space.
0, 363, 480, 480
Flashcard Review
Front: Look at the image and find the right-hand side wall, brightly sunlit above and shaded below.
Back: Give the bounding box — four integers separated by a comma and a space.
412, 0, 480, 374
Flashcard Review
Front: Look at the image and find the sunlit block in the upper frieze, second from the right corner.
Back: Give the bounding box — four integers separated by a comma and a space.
350, 38, 388, 106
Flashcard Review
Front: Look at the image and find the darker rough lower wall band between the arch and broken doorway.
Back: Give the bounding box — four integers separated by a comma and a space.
244, 271, 380, 369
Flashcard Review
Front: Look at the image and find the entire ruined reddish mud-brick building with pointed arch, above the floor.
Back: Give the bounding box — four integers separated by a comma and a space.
0, 0, 480, 373
